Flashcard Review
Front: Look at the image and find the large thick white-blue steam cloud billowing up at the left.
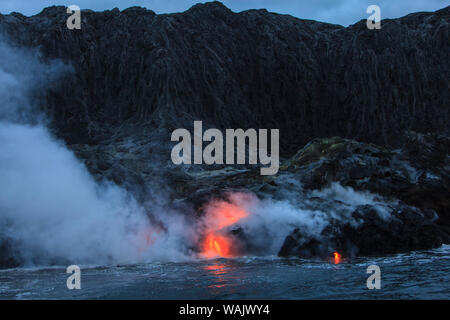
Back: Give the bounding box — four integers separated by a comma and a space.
0, 41, 195, 265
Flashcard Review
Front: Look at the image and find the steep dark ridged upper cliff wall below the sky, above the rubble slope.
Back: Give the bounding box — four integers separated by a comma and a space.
0, 2, 450, 155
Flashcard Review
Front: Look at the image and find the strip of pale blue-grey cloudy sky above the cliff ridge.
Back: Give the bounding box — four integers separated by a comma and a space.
0, 0, 450, 26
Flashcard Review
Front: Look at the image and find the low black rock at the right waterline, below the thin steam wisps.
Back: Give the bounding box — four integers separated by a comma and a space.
278, 204, 442, 258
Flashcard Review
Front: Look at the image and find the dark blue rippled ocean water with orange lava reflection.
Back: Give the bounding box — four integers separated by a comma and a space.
0, 246, 450, 299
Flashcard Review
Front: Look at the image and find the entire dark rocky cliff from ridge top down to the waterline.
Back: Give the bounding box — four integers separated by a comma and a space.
0, 2, 450, 267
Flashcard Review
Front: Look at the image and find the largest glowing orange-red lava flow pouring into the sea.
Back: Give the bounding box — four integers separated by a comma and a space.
201, 201, 248, 259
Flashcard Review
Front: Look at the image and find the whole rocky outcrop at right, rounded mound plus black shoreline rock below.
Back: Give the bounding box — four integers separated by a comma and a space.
279, 132, 450, 257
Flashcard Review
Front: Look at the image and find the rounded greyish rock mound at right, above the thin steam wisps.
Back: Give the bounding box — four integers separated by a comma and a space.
280, 132, 450, 221
